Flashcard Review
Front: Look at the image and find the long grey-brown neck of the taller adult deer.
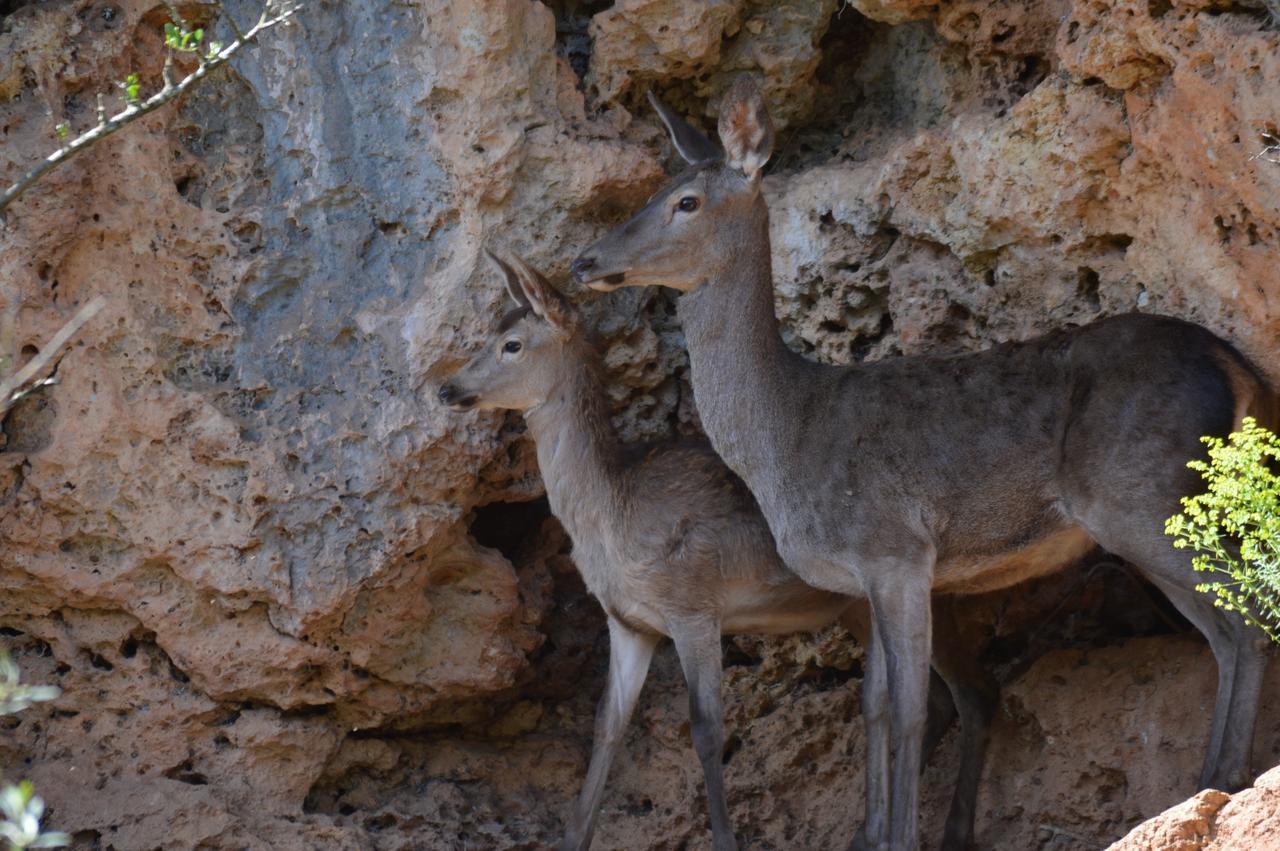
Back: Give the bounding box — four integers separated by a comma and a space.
678, 197, 812, 481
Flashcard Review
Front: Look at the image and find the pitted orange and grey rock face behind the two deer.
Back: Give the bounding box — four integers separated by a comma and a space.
0, 0, 1280, 850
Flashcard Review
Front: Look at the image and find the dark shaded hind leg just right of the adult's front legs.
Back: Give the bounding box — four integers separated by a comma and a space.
933, 598, 1000, 851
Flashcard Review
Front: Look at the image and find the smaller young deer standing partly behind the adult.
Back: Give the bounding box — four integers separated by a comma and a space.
439, 249, 995, 851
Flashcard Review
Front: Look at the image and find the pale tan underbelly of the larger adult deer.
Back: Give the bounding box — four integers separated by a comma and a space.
933, 526, 1094, 594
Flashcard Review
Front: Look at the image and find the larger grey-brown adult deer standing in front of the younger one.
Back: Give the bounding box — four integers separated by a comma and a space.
572, 77, 1277, 851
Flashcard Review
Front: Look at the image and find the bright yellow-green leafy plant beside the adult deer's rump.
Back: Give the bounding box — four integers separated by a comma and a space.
1165, 417, 1280, 642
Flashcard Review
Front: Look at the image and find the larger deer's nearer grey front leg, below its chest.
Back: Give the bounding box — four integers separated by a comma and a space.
869, 562, 932, 851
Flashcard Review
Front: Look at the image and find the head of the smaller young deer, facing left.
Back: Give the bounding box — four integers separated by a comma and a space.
438, 251, 577, 411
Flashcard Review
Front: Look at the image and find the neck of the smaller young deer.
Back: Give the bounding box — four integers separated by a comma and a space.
525, 343, 623, 547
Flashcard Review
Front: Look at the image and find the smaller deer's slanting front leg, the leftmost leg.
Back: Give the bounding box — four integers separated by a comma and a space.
561, 618, 658, 851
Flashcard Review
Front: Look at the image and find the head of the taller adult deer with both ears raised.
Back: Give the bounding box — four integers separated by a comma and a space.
572, 76, 773, 292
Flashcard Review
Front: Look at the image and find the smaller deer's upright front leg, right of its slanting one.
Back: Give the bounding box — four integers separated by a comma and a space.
671, 619, 737, 851
